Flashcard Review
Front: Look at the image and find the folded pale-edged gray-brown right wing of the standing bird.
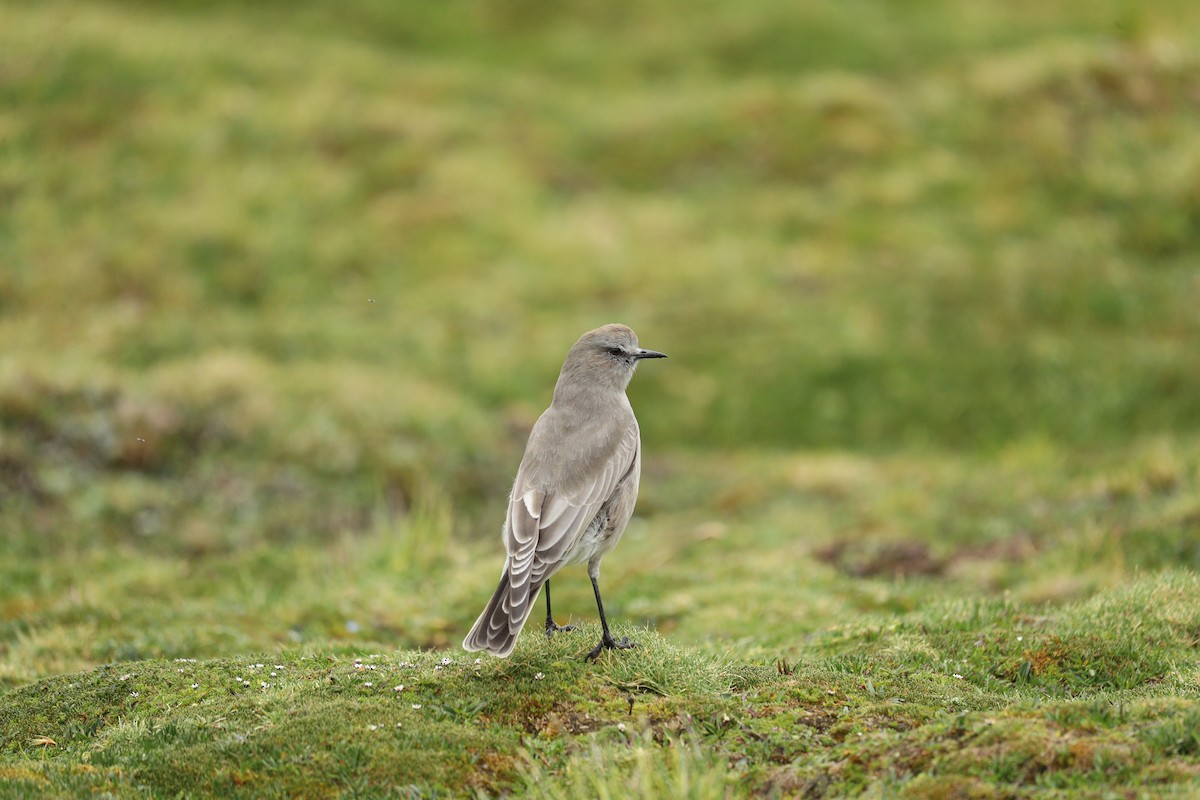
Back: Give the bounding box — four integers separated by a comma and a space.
505, 423, 638, 606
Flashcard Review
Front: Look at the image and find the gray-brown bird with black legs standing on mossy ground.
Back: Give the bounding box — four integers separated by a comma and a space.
462, 324, 666, 660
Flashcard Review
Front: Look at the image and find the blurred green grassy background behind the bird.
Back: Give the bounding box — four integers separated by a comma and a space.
0, 0, 1200, 685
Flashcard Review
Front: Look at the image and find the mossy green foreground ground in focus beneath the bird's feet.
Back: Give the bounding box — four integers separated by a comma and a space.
0, 572, 1200, 798
